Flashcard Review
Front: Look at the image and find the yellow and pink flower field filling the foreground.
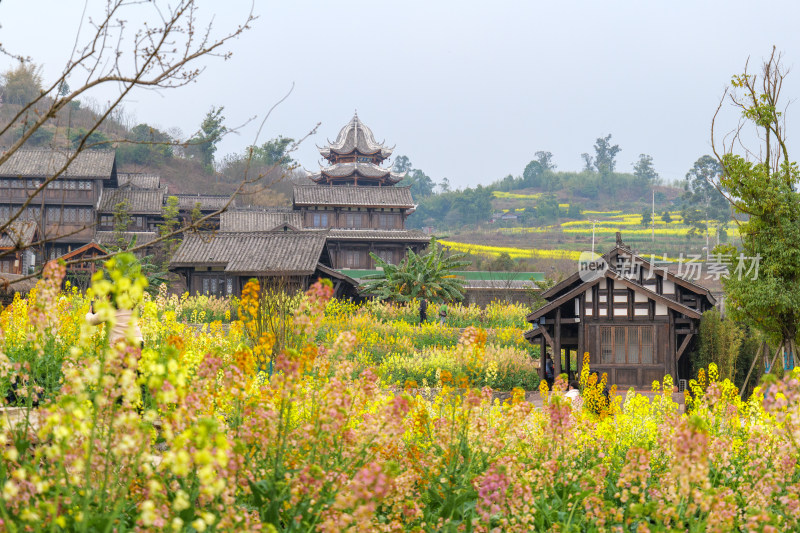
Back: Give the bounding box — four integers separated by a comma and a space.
0, 267, 800, 532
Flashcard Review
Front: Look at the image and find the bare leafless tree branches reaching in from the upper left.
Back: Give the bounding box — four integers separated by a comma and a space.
0, 0, 316, 286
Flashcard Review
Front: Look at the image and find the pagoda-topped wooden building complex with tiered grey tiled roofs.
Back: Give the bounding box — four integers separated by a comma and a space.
170, 115, 430, 295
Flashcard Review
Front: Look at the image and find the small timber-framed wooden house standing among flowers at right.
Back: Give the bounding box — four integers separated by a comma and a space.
525, 234, 716, 388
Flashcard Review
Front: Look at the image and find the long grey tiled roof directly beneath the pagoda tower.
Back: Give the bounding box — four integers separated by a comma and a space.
293, 185, 414, 208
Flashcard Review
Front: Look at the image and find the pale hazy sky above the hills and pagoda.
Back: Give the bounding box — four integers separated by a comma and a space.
0, 0, 800, 188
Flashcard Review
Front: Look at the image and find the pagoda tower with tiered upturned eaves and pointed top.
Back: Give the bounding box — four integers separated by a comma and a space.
309, 113, 405, 187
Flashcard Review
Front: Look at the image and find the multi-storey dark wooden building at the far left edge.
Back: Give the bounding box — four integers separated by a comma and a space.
0, 149, 118, 259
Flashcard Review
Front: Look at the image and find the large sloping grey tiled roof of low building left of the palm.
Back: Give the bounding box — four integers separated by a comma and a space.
170, 232, 325, 275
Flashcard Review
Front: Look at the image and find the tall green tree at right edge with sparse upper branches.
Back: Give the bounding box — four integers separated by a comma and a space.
712, 49, 800, 366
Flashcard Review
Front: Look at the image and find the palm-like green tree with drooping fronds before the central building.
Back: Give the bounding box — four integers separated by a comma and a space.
362, 237, 470, 302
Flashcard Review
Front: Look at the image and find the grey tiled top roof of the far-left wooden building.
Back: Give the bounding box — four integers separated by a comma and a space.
0, 149, 116, 179
